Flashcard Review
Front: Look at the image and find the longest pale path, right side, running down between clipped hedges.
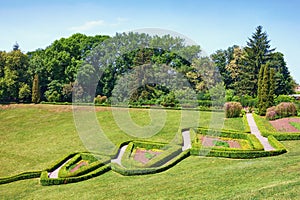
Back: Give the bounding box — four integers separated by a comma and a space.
247, 113, 275, 151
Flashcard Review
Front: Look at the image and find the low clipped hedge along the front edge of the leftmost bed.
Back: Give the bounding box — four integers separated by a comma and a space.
40, 164, 111, 186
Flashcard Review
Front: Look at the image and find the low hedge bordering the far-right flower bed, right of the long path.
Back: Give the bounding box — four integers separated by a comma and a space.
253, 114, 300, 141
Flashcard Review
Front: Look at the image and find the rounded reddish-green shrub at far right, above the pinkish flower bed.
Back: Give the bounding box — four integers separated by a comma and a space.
266, 102, 297, 120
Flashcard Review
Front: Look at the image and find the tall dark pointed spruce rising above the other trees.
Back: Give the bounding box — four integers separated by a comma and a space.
244, 26, 275, 96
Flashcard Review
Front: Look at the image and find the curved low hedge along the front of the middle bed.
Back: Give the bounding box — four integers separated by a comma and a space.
111, 150, 190, 176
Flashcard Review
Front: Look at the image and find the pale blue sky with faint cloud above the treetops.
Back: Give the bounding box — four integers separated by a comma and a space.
0, 0, 300, 83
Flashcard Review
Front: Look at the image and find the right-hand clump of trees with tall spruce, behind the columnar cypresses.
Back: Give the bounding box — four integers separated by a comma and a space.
211, 26, 295, 98
